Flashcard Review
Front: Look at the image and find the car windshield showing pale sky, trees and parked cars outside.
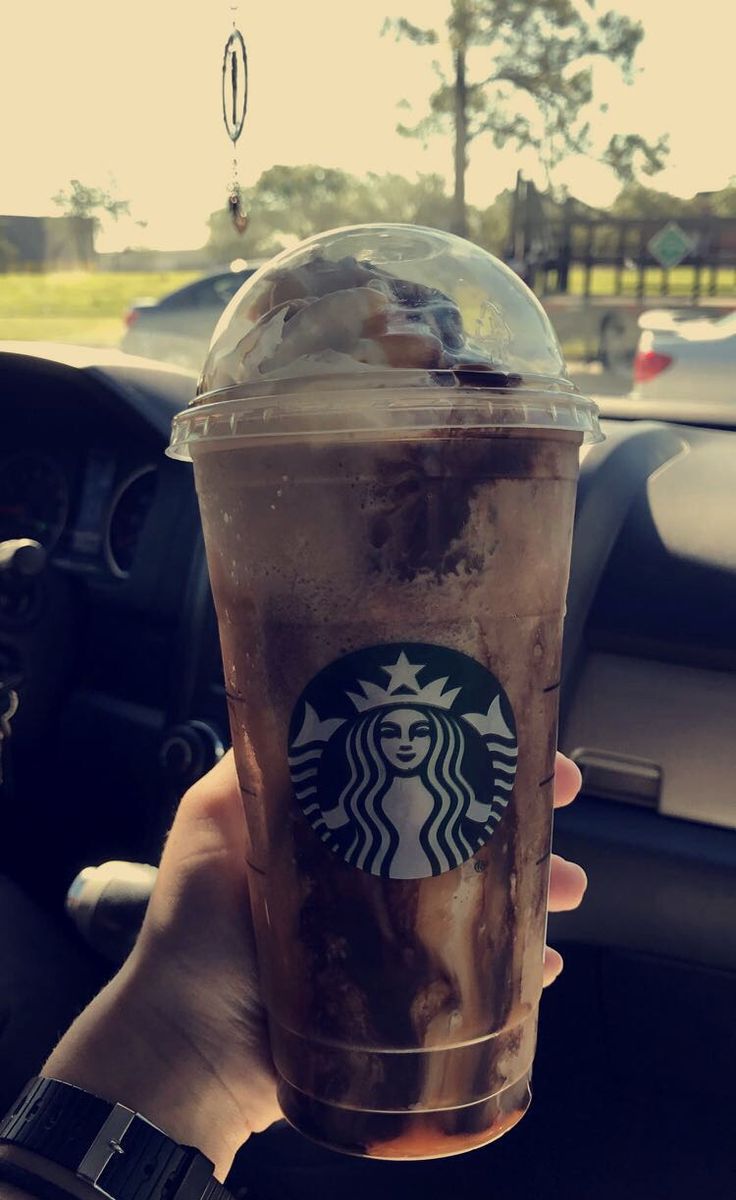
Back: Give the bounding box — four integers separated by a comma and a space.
0, 0, 736, 404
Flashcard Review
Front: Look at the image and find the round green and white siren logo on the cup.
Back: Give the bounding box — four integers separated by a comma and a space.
289, 642, 519, 880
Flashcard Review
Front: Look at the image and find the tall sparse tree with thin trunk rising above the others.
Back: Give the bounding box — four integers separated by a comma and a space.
384, 0, 668, 235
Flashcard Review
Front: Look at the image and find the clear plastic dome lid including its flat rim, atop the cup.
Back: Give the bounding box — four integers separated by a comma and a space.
169, 224, 600, 457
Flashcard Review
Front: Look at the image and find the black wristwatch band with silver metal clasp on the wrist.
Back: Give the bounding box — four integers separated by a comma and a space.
0, 1078, 232, 1200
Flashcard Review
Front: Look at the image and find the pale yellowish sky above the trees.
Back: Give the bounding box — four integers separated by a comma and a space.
0, 0, 736, 250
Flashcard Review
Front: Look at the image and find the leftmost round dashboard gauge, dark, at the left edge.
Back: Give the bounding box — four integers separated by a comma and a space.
0, 451, 68, 550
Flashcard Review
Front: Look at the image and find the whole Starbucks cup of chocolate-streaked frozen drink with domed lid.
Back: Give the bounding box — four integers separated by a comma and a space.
170, 226, 599, 1159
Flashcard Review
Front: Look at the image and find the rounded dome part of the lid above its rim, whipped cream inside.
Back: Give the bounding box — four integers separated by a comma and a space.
198, 224, 564, 395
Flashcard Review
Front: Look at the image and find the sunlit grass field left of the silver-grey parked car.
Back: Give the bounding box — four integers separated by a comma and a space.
0, 271, 202, 346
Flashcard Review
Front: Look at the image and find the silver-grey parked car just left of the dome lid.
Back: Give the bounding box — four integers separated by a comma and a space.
120, 266, 256, 371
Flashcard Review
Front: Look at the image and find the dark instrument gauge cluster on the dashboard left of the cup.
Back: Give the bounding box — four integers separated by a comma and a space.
0, 448, 158, 580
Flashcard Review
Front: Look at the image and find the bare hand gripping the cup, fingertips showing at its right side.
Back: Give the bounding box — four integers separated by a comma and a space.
44, 754, 586, 1178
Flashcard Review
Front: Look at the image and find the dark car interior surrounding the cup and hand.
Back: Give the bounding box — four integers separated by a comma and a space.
0, 346, 736, 1200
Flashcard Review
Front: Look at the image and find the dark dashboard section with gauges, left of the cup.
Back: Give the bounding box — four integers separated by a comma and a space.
0, 347, 212, 902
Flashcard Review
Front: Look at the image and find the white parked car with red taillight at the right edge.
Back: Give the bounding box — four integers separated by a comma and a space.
634, 310, 736, 402
